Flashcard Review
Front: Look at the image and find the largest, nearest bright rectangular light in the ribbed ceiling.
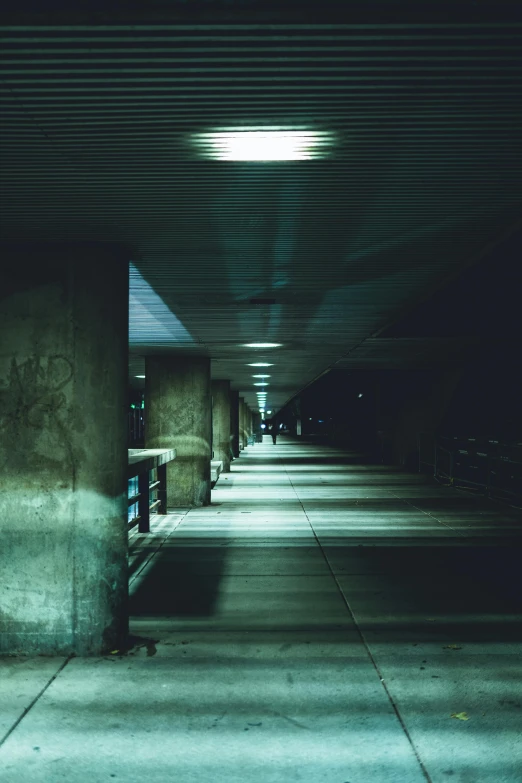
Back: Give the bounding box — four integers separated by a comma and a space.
192, 127, 333, 161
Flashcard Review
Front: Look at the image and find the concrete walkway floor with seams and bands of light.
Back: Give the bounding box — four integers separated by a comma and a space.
0, 438, 522, 783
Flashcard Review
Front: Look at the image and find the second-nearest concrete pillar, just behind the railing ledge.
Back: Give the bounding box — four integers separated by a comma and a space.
145, 355, 212, 508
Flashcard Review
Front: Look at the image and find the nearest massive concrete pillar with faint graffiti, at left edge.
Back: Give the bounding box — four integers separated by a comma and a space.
0, 243, 129, 655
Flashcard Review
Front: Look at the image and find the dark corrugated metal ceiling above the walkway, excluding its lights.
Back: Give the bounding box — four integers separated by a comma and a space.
1, 9, 522, 408
